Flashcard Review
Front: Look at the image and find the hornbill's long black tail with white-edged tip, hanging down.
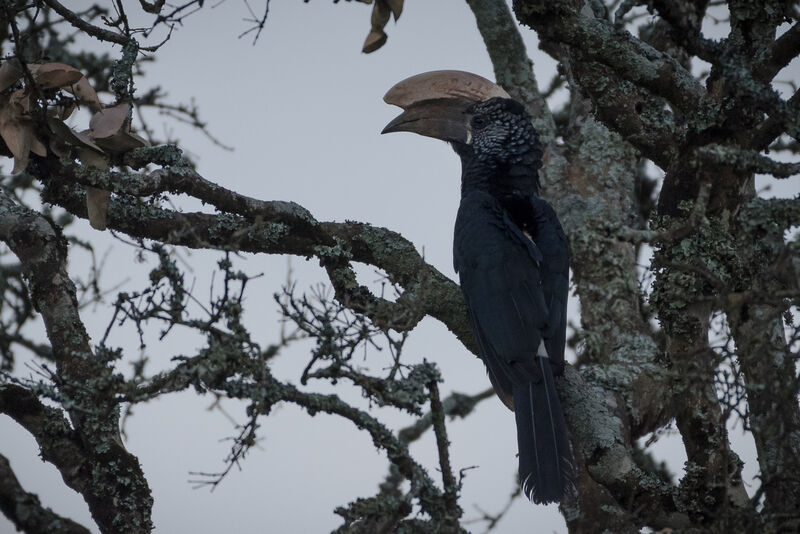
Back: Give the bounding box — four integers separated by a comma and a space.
513, 357, 575, 504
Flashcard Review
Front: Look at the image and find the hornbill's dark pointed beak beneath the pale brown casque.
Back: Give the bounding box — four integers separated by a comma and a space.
381, 98, 474, 143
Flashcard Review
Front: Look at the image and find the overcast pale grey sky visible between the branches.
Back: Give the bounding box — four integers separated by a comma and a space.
0, 0, 792, 533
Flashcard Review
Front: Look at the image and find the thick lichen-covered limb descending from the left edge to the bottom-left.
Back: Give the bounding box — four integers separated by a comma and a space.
0, 190, 152, 534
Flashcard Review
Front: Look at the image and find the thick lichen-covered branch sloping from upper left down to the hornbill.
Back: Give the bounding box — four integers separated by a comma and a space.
36, 156, 477, 352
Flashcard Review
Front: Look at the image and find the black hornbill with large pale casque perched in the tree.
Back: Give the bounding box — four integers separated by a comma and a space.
382, 71, 574, 503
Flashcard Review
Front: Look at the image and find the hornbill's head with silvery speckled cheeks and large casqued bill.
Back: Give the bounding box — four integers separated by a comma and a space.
381, 71, 541, 171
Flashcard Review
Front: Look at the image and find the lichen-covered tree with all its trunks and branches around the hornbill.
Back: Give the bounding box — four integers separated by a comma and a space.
0, 0, 800, 533
